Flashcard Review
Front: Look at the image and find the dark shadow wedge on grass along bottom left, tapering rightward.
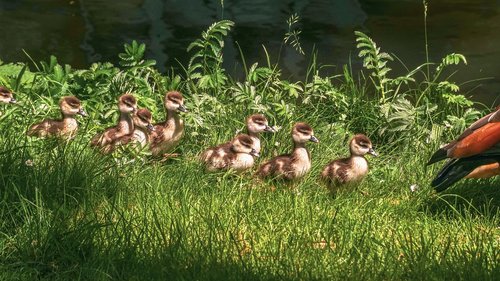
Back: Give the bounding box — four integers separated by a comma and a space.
0, 213, 292, 280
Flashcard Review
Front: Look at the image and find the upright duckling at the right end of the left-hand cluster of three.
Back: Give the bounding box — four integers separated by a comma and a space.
150, 91, 187, 156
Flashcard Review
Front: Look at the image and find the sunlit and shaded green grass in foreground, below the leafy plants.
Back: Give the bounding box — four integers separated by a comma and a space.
0, 120, 500, 280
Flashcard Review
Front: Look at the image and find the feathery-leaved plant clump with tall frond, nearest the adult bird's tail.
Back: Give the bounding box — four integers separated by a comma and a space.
355, 31, 478, 145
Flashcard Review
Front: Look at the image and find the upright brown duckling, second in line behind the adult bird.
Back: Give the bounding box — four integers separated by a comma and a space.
257, 122, 319, 180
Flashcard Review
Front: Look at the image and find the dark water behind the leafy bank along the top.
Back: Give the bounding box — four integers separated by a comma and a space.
0, 0, 500, 105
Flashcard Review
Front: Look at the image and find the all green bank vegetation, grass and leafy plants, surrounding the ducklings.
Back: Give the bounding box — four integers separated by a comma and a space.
0, 14, 500, 280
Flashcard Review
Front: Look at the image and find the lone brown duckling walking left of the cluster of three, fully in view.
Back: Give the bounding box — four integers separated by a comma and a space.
27, 96, 87, 140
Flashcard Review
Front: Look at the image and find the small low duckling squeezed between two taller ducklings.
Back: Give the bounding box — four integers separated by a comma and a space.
113, 108, 154, 147
